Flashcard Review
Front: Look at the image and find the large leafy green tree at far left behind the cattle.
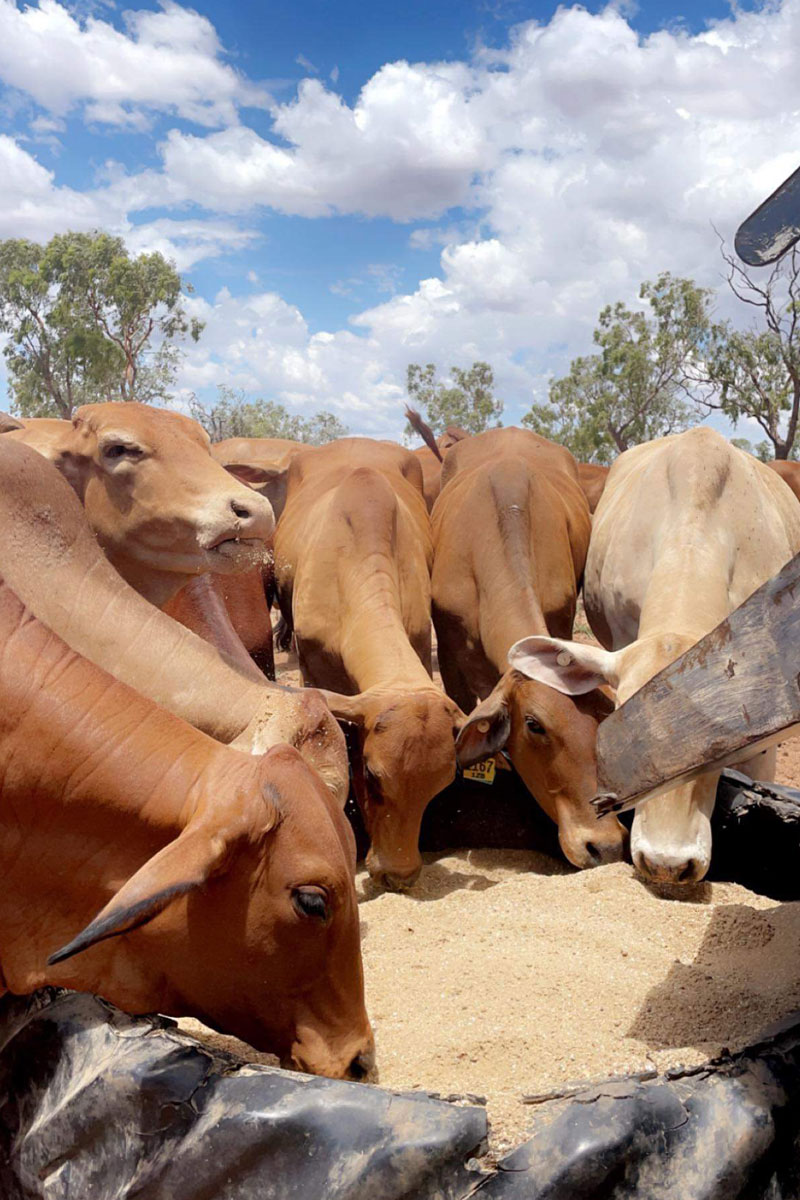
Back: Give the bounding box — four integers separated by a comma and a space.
0, 233, 203, 418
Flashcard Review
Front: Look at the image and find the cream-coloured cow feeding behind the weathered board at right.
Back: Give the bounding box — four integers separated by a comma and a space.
510, 428, 800, 883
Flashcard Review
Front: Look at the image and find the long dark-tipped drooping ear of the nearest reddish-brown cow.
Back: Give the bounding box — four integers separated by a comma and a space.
47, 823, 241, 966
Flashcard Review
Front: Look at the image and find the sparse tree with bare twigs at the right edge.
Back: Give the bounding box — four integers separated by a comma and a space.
702, 250, 800, 458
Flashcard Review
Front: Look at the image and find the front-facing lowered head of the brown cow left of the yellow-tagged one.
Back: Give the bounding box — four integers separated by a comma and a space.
323, 688, 464, 890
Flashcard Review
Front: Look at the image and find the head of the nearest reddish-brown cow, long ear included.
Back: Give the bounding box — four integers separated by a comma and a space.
47, 746, 374, 1079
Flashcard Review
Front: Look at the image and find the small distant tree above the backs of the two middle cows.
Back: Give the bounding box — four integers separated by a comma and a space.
405, 362, 503, 436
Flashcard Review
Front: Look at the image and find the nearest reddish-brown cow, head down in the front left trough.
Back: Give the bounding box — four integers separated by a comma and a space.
0, 575, 373, 1079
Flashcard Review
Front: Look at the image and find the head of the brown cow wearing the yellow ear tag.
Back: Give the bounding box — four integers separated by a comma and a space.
457, 668, 626, 868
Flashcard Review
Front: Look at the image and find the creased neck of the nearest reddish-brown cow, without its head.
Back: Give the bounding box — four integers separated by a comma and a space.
0, 583, 258, 844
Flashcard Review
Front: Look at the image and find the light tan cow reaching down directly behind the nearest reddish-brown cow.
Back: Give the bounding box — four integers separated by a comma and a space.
0, 437, 349, 808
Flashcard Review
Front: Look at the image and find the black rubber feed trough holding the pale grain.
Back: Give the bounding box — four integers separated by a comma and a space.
0, 773, 800, 1200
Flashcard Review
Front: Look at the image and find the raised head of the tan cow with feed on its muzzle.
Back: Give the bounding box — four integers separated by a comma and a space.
16, 403, 275, 605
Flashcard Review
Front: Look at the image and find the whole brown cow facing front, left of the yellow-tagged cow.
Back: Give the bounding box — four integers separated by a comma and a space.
275, 438, 463, 888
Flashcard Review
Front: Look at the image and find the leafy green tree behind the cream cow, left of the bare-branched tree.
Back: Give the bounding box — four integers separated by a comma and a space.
522, 272, 711, 463
